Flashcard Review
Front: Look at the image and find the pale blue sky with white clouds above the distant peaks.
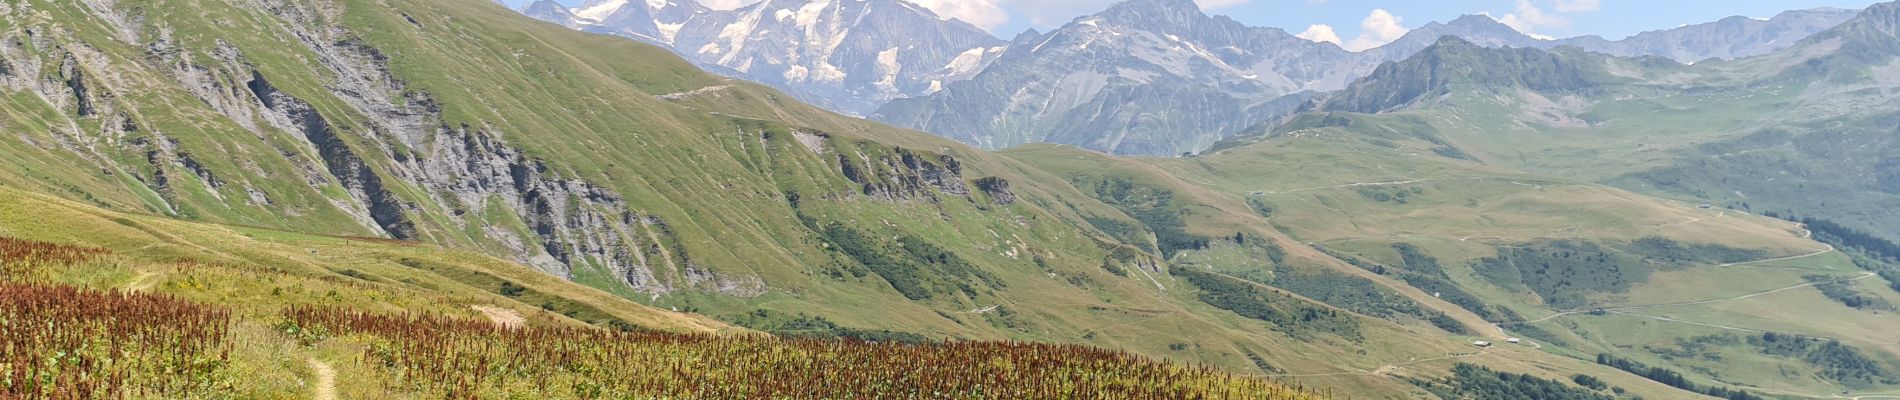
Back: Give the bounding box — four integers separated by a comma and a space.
505, 0, 1873, 49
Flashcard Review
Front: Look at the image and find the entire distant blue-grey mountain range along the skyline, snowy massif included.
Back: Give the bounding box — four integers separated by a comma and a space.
523, 0, 1854, 155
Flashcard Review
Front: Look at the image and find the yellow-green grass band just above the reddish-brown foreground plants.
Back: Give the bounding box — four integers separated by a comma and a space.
0, 188, 725, 334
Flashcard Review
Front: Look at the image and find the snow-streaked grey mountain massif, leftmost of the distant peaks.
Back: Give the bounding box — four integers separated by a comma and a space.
523, 0, 1003, 116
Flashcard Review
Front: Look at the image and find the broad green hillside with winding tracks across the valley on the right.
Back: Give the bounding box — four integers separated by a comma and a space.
1147, 4, 1900, 398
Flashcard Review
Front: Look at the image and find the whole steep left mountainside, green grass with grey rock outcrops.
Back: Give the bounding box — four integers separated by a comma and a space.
0, 0, 1527, 396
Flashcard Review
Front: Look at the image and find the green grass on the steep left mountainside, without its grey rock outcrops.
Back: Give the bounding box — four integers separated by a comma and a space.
0, 0, 1504, 396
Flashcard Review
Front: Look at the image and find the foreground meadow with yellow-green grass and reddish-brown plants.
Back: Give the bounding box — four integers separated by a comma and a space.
0, 190, 1317, 400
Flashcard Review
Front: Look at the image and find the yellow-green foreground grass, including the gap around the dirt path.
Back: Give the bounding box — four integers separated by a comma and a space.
0, 188, 733, 398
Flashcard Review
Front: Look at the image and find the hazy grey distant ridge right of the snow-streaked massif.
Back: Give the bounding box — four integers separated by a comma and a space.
870, 2, 1851, 155
